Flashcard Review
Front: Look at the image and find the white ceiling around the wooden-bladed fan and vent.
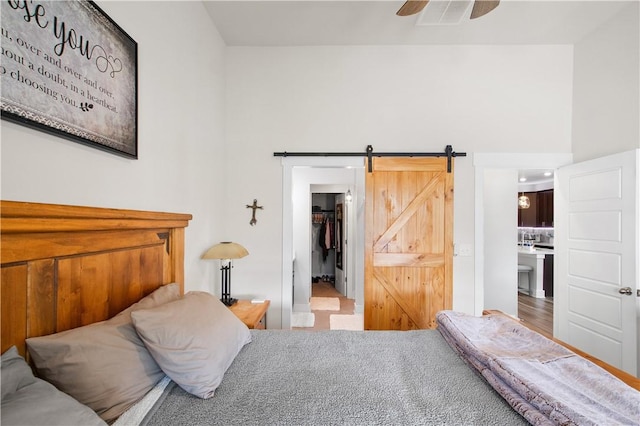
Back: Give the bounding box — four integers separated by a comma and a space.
203, 0, 638, 46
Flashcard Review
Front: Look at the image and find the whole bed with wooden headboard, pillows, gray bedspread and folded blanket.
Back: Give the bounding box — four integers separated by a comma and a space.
0, 201, 640, 425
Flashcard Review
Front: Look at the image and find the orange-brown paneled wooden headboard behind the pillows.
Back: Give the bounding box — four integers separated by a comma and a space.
0, 201, 191, 355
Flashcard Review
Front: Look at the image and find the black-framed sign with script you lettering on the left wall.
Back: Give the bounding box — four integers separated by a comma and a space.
0, 0, 138, 158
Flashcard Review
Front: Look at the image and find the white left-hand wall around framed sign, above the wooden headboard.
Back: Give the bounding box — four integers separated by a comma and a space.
0, 1, 227, 291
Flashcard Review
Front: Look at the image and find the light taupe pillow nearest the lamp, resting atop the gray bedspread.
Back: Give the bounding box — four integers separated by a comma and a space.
131, 292, 251, 398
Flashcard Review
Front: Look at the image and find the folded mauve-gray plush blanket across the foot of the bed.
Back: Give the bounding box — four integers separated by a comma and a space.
436, 311, 640, 425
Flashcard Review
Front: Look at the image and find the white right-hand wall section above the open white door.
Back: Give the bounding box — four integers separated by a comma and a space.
573, 2, 640, 162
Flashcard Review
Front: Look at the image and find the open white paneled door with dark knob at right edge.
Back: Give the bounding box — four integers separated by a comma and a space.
554, 150, 640, 376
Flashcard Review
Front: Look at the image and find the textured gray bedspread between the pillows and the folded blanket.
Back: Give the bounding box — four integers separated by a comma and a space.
143, 330, 527, 425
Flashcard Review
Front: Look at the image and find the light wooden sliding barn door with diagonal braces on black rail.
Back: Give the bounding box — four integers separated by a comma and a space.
364, 157, 453, 330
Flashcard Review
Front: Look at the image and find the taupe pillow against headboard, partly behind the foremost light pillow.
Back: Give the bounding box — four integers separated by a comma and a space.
27, 284, 180, 422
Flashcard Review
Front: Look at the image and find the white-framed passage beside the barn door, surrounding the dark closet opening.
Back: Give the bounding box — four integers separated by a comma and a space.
281, 157, 365, 329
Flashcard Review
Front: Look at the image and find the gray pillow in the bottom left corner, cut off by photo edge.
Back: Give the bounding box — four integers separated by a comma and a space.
0, 346, 106, 426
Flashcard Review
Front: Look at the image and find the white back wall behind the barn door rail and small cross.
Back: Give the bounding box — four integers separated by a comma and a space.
226, 46, 573, 327
